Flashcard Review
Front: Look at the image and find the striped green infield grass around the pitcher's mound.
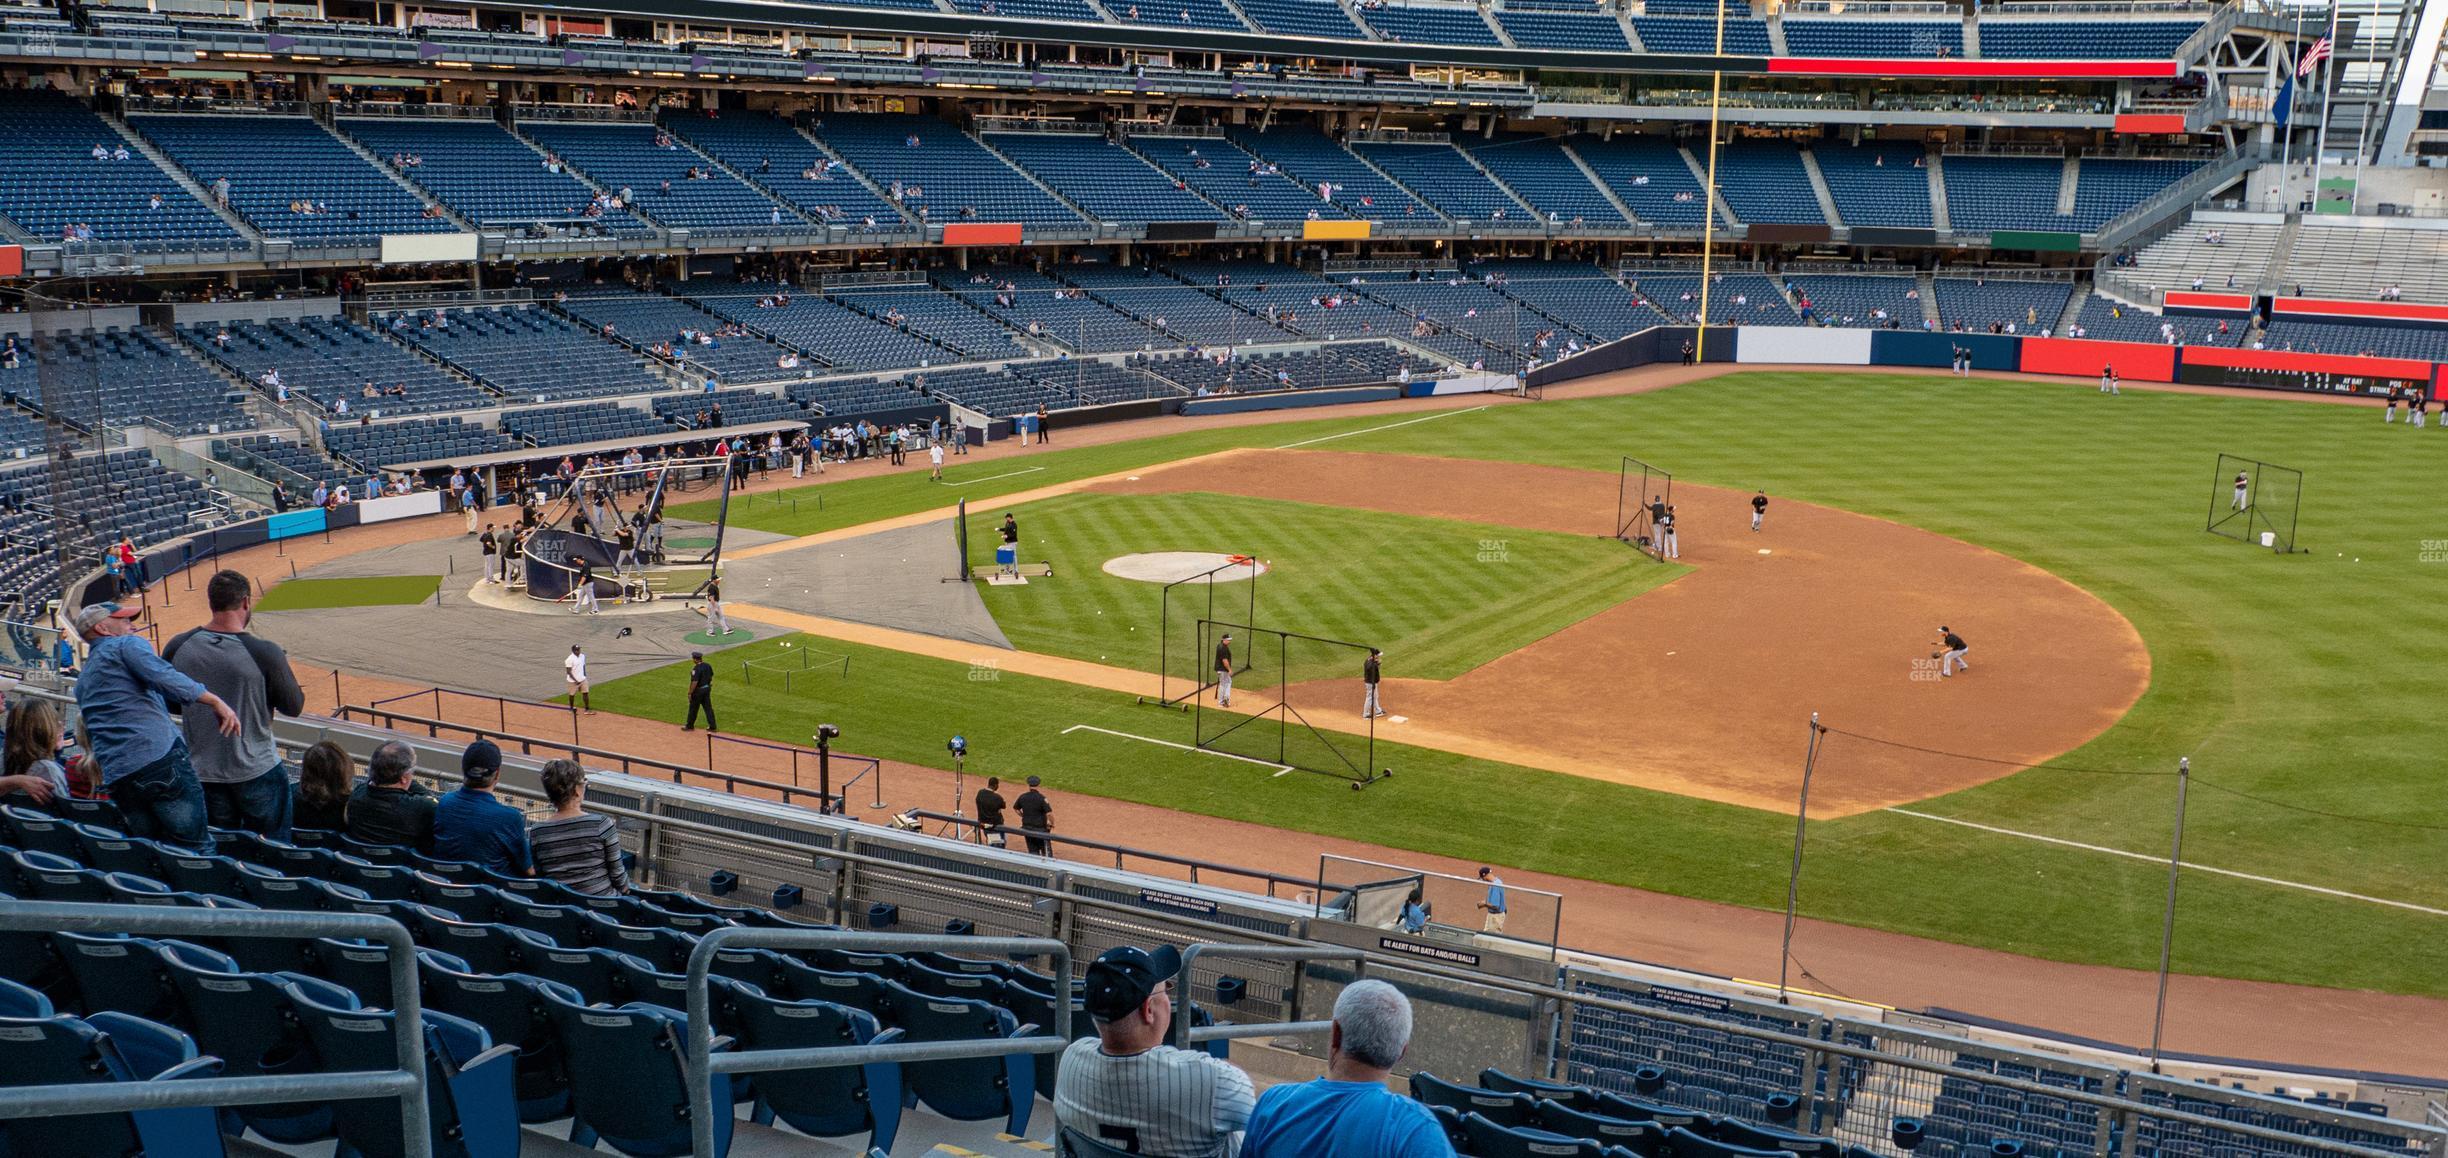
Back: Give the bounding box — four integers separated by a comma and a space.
969, 495, 1689, 688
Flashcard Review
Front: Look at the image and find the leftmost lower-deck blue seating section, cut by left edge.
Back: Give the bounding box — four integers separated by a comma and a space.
0, 331, 255, 435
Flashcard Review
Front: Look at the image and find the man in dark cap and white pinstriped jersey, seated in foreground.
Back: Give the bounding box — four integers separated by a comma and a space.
1055, 945, 1256, 1158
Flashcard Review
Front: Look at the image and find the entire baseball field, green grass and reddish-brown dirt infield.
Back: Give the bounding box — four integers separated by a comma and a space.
616, 372, 2448, 996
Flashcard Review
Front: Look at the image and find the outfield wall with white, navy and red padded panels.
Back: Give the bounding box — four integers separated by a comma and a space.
1528, 326, 2448, 399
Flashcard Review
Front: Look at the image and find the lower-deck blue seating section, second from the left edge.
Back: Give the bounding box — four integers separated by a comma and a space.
186, 318, 492, 419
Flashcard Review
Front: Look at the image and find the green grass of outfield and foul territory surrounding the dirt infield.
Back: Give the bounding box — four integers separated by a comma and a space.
626, 372, 2448, 994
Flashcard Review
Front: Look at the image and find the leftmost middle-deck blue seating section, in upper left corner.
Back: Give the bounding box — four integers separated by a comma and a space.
0, 91, 247, 252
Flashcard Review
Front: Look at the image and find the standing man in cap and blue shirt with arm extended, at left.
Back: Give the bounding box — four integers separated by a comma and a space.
71, 602, 237, 850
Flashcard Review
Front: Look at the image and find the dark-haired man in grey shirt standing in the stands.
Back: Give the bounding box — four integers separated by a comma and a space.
162, 570, 306, 840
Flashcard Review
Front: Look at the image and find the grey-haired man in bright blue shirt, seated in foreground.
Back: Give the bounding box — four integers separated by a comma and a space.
1241, 979, 1454, 1158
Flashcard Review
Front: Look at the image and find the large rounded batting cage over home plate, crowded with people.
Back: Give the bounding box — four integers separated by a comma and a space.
521, 455, 737, 602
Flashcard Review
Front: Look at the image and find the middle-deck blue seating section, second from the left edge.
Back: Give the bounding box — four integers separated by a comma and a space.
127, 115, 458, 245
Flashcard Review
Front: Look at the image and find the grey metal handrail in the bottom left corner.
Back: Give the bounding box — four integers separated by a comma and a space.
0, 901, 430, 1158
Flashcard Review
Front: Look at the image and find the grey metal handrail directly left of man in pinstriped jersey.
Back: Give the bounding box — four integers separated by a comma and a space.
690, 925, 1072, 1158
